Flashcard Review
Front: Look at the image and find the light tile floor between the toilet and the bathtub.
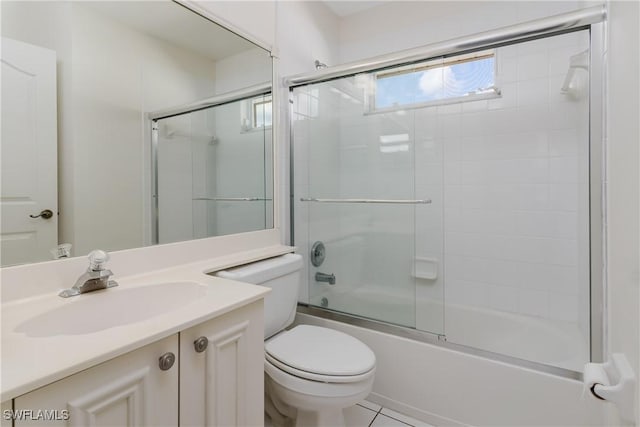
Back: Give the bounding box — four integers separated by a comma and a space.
265, 400, 433, 427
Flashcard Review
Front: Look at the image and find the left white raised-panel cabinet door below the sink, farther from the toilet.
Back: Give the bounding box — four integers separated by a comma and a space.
15, 334, 178, 427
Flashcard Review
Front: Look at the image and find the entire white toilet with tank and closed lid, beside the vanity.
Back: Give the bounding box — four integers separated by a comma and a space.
216, 254, 376, 426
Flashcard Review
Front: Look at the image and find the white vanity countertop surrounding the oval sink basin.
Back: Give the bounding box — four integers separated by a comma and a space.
0, 247, 292, 402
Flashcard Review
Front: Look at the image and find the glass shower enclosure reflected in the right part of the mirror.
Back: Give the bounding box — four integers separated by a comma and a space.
151, 86, 273, 243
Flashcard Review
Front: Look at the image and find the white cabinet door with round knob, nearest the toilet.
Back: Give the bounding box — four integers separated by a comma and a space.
180, 300, 264, 426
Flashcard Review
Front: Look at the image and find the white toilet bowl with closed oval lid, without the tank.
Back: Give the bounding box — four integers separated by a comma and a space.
264, 325, 375, 426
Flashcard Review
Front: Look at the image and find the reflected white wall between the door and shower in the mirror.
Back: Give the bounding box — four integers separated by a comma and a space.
73, 4, 220, 254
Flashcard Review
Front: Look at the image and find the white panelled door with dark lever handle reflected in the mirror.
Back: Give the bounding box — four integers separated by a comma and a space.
0, 38, 58, 266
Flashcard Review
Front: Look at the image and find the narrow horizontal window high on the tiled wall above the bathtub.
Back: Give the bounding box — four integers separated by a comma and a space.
369, 50, 499, 112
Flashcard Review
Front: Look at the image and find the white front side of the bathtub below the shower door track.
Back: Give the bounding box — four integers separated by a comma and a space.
296, 313, 608, 427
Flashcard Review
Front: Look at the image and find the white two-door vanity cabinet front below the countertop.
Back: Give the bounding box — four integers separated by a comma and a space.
12, 299, 264, 427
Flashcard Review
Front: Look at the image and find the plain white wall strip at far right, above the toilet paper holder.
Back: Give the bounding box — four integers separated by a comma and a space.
606, 1, 640, 425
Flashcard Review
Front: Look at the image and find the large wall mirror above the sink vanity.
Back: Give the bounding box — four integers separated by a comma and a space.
0, 1, 273, 266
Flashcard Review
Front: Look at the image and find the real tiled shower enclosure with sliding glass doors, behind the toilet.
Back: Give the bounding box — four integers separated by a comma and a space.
290, 12, 600, 372
